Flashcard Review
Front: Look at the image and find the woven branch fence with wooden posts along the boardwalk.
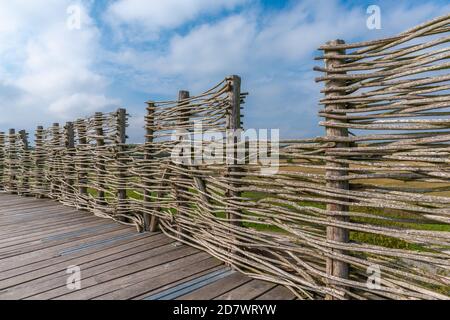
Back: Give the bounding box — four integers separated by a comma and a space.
0, 15, 450, 299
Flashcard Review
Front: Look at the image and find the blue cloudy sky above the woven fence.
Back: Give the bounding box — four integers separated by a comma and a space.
0, 0, 450, 142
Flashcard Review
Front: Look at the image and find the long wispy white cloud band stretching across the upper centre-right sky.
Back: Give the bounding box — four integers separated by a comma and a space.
107, 0, 367, 90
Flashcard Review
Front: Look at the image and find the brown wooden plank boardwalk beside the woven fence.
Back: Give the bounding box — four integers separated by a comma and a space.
0, 194, 294, 300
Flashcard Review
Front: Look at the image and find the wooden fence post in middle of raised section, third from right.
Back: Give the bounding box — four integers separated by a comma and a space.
175, 90, 191, 237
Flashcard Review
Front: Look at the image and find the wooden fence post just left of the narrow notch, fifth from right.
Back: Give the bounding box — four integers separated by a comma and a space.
116, 108, 127, 220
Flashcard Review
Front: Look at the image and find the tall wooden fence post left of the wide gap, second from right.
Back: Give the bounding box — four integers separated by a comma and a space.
226, 75, 241, 226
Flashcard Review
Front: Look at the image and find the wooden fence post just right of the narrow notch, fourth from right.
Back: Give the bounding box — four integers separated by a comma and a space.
144, 102, 158, 232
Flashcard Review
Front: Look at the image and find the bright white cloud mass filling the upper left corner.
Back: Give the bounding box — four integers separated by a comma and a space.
0, 0, 118, 130
